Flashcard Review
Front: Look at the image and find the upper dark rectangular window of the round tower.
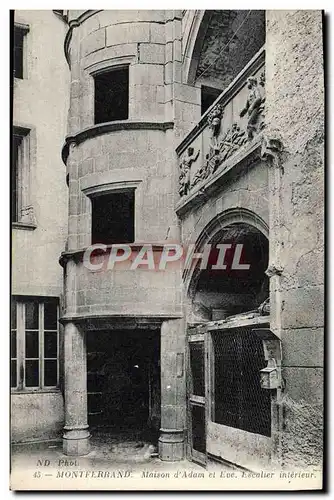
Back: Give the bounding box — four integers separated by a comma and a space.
95, 68, 129, 123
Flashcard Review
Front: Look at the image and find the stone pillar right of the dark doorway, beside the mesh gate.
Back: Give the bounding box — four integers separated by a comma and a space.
159, 319, 186, 462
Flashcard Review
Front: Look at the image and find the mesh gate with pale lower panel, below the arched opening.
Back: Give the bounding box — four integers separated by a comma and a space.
188, 319, 276, 468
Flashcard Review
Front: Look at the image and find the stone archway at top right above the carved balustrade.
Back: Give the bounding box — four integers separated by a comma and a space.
183, 10, 265, 90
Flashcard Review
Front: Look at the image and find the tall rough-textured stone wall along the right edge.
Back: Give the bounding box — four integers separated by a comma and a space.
266, 11, 324, 466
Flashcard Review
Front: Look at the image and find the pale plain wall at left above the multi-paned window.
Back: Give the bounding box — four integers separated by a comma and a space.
12, 10, 69, 296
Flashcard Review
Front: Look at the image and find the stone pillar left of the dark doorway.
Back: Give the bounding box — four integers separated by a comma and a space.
63, 322, 90, 456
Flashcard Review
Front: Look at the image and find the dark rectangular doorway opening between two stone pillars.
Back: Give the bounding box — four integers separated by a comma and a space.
87, 330, 160, 439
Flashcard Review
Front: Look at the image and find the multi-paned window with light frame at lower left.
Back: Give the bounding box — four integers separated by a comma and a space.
11, 298, 59, 389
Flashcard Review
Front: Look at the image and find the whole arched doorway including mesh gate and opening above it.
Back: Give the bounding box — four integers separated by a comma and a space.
188, 217, 276, 467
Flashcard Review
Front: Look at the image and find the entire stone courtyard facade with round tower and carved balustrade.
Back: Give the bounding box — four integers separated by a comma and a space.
12, 10, 324, 469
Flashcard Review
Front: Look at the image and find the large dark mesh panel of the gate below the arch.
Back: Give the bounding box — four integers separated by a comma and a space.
212, 328, 271, 436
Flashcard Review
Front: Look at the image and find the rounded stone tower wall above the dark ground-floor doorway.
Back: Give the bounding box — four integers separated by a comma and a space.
66, 10, 182, 315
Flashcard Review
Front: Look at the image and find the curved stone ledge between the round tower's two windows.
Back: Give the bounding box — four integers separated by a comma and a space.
61, 120, 174, 165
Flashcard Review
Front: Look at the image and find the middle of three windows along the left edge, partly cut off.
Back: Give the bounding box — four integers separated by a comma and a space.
11, 127, 34, 224
